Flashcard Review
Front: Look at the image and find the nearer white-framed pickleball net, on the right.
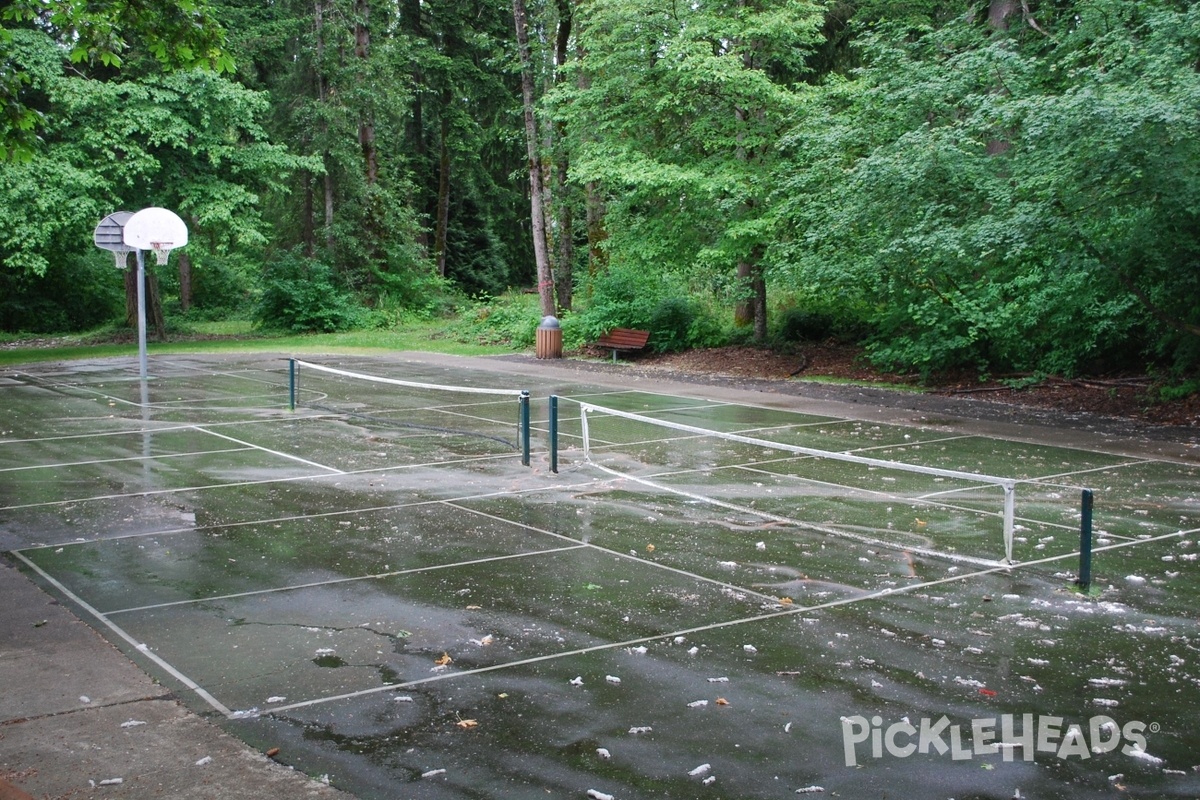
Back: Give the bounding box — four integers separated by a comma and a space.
553, 402, 1019, 566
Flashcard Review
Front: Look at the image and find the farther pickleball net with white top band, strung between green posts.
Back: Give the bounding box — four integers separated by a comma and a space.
288, 359, 530, 467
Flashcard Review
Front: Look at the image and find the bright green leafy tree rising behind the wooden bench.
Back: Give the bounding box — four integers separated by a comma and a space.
554, 0, 823, 339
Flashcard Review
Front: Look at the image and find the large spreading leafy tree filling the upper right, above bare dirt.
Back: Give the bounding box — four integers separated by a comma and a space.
774, 0, 1200, 374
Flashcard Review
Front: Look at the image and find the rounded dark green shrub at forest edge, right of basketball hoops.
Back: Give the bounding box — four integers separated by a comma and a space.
254, 251, 368, 333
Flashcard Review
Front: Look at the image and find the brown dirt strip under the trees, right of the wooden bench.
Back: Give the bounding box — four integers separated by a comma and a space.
576, 344, 1200, 427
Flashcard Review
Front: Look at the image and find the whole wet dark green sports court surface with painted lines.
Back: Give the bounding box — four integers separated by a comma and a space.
0, 356, 1200, 799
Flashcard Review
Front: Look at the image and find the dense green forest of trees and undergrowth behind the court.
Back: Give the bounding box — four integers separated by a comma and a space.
0, 0, 1200, 393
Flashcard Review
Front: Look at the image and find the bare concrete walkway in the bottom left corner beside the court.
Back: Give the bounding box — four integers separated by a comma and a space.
0, 557, 349, 800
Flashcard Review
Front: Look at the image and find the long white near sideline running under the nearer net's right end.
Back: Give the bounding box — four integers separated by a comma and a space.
253, 529, 1200, 718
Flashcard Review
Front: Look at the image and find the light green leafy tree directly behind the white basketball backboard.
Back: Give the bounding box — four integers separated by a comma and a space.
0, 25, 314, 331
